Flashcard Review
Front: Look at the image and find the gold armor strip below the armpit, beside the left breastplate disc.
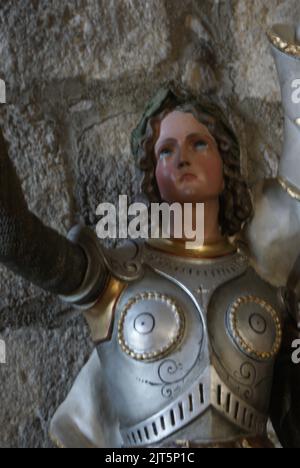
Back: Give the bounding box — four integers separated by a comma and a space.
84, 276, 127, 343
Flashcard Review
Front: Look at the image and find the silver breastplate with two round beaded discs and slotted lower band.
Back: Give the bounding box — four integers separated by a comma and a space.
98, 243, 281, 446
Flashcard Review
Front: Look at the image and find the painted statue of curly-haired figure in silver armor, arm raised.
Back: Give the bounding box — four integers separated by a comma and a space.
0, 23, 300, 448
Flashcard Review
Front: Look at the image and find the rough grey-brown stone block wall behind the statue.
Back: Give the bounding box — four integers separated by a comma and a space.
0, 0, 300, 447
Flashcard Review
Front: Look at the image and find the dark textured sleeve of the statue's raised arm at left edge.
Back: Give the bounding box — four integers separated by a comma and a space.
0, 131, 87, 295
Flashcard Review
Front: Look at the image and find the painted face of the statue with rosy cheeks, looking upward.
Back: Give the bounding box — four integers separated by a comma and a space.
155, 111, 224, 203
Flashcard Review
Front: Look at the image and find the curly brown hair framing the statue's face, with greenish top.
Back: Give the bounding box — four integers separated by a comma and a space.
132, 87, 253, 236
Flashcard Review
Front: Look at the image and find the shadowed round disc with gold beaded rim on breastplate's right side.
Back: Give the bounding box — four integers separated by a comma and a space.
227, 296, 282, 361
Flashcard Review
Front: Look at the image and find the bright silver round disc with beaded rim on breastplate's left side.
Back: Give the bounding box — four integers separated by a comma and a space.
118, 292, 185, 361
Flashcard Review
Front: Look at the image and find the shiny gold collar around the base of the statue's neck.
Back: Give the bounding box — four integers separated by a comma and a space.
147, 237, 237, 258
